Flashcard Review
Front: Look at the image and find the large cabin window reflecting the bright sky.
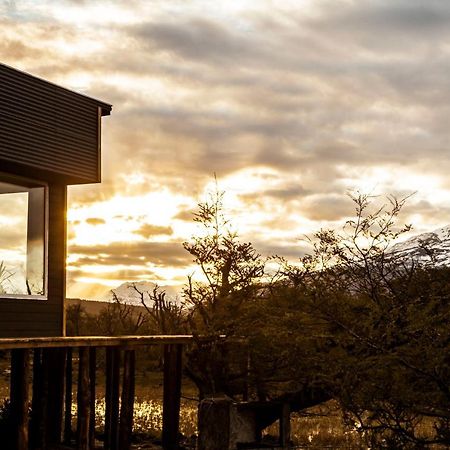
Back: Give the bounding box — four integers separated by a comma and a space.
0, 174, 47, 298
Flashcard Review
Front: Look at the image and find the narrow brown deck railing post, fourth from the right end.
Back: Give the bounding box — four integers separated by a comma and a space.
77, 347, 90, 450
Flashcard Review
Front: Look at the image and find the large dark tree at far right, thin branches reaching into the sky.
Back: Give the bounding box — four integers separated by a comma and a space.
286, 195, 450, 449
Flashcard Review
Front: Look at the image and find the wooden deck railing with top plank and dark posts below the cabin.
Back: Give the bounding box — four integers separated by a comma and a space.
0, 335, 193, 450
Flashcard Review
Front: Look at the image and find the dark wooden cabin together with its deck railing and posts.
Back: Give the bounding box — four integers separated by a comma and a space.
0, 64, 188, 450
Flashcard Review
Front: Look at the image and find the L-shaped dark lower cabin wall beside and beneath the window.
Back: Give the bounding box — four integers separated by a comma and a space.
0, 184, 67, 338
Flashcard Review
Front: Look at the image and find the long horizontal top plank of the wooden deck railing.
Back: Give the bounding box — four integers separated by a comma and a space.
0, 335, 199, 350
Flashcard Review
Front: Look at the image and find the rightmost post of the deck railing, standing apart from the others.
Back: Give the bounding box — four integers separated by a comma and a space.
162, 344, 183, 450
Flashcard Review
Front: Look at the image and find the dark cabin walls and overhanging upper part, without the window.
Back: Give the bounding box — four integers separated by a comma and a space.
0, 64, 111, 337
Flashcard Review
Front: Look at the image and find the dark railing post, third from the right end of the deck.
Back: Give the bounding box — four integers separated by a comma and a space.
104, 347, 120, 450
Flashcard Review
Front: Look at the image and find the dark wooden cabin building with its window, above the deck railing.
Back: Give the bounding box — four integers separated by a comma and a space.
0, 64, 111, 337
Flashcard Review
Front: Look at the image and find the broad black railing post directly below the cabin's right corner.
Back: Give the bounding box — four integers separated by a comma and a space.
45, 348, 66, 446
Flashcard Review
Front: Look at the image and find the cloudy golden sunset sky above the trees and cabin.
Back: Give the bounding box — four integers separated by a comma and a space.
0, 0, 450, 298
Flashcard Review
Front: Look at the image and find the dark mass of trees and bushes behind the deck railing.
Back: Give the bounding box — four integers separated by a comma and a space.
68, 193, 450, 449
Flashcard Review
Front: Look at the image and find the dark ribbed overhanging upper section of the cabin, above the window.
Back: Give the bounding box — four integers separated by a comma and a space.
0, 64, 111, 184
